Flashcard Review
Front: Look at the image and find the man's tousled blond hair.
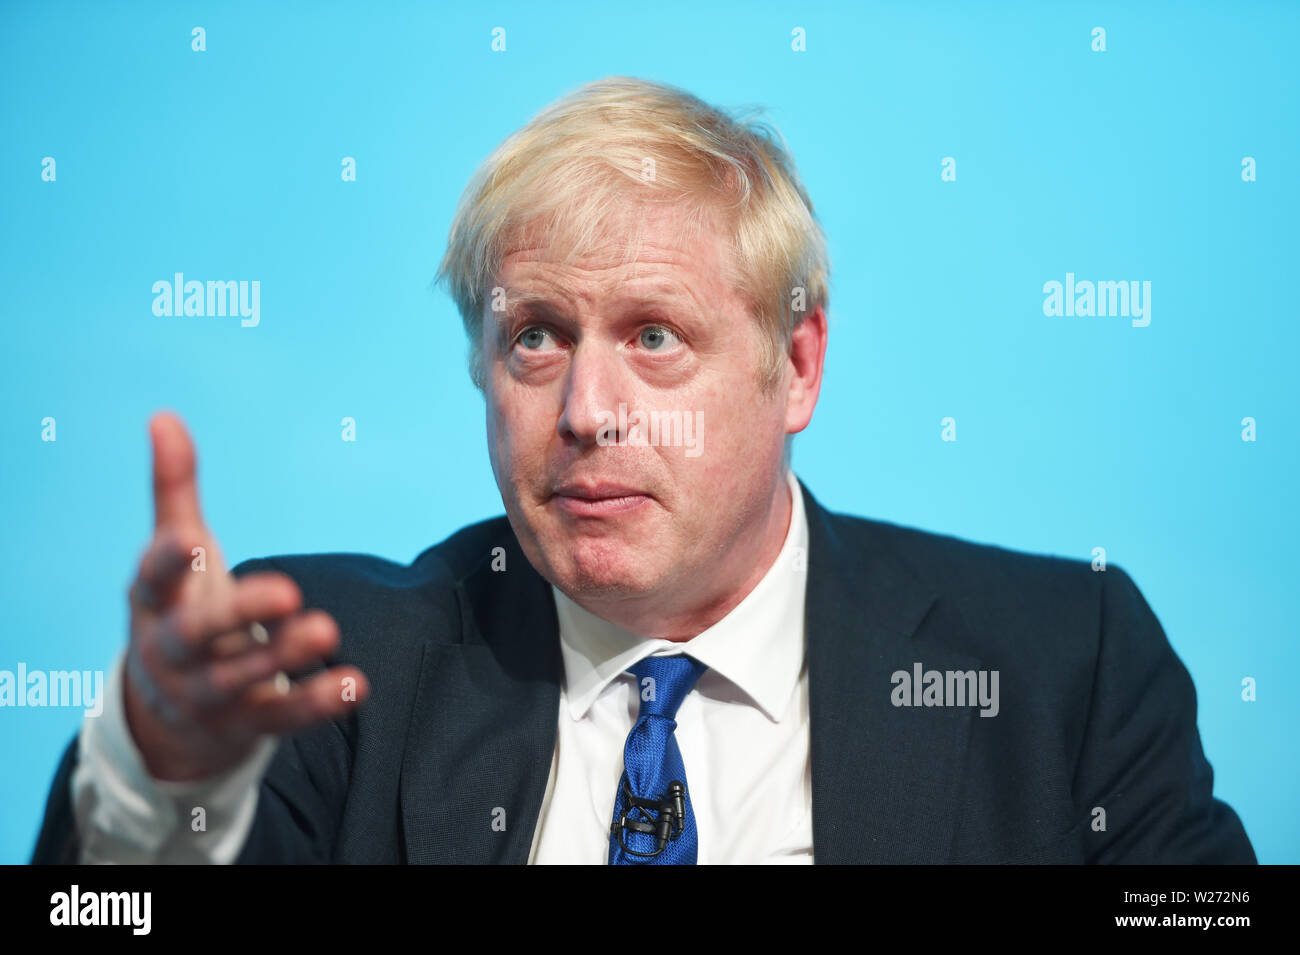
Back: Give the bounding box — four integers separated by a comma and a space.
434, 77, 829, 388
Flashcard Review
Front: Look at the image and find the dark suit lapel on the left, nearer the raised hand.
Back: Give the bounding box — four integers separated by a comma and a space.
400, 535, 562, 864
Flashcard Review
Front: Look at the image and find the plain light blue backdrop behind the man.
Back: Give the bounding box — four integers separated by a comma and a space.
0, 1, 1300, 863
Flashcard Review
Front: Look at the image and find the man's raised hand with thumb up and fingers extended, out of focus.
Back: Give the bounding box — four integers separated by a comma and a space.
122, 413, 369, 780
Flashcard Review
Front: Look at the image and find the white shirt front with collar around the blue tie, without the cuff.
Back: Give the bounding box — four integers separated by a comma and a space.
529, 474, 813, 865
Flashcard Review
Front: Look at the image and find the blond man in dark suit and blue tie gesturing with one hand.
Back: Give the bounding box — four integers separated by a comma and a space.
35, 79, 1255, 864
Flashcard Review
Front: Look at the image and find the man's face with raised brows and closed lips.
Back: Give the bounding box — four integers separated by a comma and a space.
482, 207, 787, 631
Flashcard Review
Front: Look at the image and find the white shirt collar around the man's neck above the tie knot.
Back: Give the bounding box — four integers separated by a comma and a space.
551, 470, 809, 721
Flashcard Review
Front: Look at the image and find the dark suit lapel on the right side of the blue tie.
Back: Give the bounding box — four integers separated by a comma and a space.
801, 485, 979, 864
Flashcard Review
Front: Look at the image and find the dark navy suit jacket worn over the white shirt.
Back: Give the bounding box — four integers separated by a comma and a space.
34, 487, 1256, 863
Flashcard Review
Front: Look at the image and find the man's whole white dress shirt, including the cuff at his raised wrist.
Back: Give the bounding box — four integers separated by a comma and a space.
72, 472, 813, 865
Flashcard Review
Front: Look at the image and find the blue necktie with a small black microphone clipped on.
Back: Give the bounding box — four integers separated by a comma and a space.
610, 656, 709, 865
